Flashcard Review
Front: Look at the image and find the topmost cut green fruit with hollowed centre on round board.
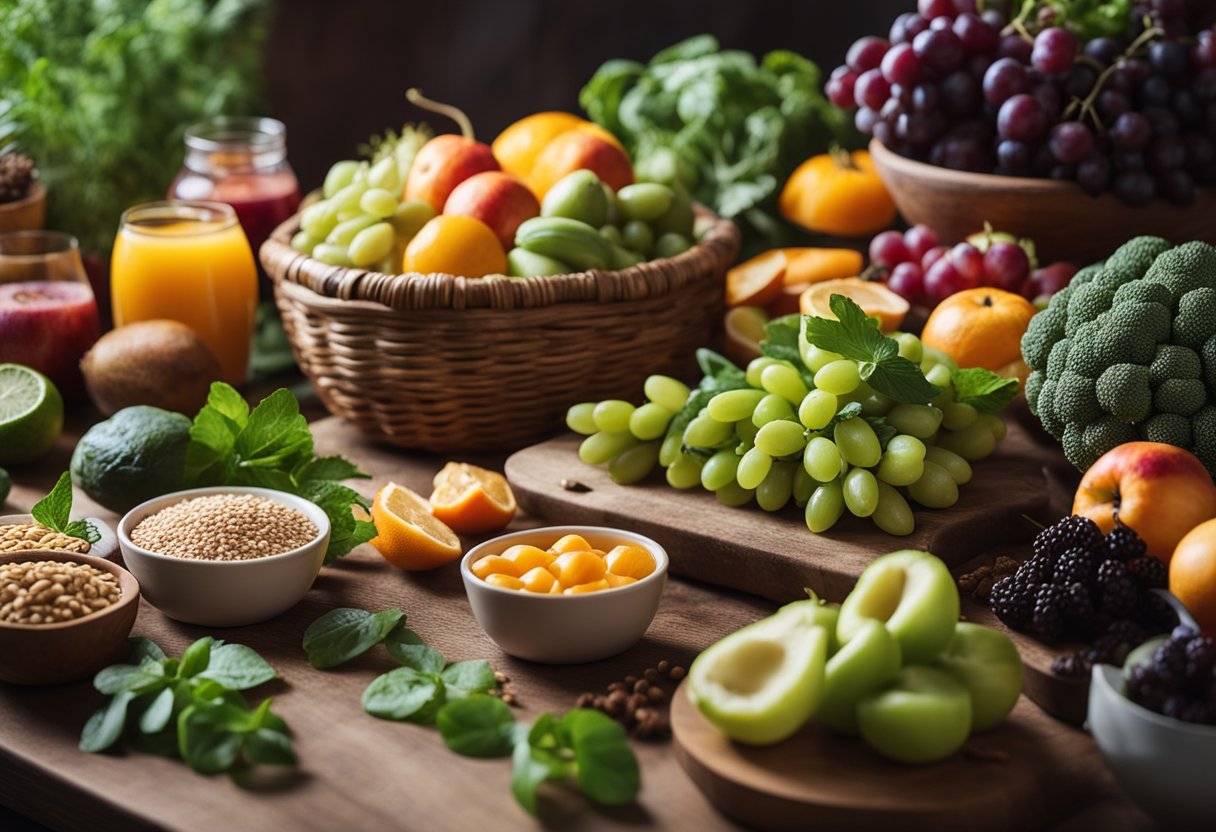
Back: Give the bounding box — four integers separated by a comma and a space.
837, 549, 959, 664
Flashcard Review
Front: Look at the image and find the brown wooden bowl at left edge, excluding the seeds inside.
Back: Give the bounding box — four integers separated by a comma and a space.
0, 550, 140, 685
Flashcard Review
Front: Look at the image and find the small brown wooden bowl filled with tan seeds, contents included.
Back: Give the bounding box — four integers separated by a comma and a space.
0, 550, 140, 685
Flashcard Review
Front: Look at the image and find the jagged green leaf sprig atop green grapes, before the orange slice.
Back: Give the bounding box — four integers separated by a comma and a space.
806, 294, 941, 404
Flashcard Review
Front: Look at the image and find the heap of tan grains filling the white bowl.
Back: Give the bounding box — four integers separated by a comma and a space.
131, 494, 317, 561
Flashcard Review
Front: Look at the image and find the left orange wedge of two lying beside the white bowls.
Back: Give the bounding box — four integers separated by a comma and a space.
371, 483, 462, 572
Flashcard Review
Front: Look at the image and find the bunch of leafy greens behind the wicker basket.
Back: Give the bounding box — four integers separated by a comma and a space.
579, 35, 857, 246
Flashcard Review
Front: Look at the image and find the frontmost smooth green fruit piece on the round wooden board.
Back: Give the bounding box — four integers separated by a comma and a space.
857, 665, 972, 763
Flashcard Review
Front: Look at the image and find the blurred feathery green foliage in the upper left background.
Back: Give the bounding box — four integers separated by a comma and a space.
0, 0, 270, 253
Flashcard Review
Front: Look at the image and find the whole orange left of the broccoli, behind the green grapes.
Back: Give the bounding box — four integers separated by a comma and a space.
921, 288, 1035, 376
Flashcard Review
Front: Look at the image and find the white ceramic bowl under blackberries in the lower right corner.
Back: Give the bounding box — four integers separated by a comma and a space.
1088, 664, 1216, 830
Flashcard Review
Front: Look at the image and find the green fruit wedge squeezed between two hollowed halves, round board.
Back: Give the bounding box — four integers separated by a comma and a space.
815, 619, 900, 733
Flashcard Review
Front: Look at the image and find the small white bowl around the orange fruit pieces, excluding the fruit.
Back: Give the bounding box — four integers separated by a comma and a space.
460, 525, 668, 664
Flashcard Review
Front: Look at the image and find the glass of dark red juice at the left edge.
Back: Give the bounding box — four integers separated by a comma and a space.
0, 231, 101, 399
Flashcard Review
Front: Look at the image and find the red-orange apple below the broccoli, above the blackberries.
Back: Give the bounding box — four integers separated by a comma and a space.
1073, 442, 1216, 566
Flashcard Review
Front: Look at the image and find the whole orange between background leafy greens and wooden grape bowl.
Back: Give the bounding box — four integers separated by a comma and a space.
777, 151, 895, 237
